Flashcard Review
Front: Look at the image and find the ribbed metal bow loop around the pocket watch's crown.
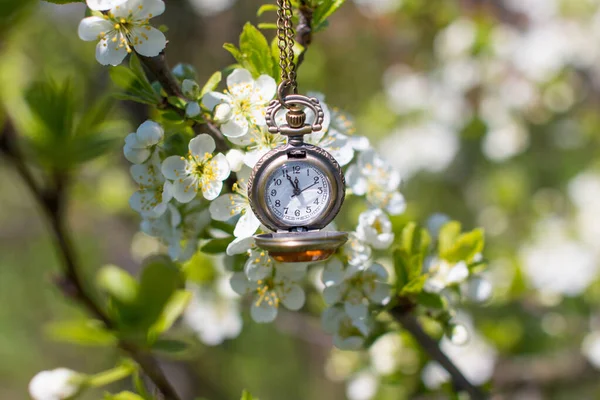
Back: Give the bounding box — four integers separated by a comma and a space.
265, 94, 325, 136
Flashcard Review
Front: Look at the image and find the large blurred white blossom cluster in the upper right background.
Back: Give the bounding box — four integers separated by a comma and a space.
378, 0, 600, 179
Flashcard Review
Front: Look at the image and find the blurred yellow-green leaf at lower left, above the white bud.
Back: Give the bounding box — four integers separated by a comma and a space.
45, 319, 117, 346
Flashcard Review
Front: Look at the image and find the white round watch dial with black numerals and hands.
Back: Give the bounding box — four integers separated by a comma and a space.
265, 161, 331, 226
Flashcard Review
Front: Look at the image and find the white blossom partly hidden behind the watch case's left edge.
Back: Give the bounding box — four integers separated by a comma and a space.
210, 168, 260, 237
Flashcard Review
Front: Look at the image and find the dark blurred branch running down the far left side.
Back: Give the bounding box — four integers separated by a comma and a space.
0, 122, 180, 400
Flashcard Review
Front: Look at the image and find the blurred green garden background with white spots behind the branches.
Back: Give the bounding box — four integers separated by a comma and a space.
0, 0, 600, 400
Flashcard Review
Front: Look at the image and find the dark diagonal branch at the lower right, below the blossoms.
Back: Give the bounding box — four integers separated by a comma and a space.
391, 307, 488, 400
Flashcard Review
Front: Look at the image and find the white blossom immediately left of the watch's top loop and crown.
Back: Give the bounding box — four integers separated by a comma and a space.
202, 68, 277, 138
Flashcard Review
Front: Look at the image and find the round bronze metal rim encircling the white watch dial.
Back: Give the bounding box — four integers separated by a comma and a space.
248, 142, 346, 231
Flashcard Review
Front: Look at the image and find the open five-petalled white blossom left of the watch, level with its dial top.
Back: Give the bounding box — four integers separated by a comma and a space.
162, 134, 230, 203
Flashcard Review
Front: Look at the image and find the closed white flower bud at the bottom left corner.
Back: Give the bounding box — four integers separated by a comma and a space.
29, 368, 83, 400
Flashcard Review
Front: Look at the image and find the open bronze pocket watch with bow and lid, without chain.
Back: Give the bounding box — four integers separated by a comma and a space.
248, 94, 348, 262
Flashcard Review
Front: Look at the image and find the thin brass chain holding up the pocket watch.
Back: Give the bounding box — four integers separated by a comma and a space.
277, 0, 298, 93
